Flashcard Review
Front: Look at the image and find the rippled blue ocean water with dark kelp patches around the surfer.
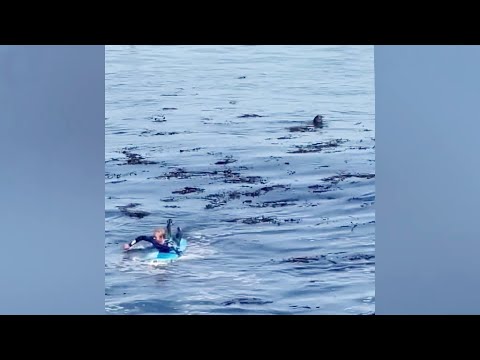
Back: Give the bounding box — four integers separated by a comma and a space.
105, 46, 375, 315
